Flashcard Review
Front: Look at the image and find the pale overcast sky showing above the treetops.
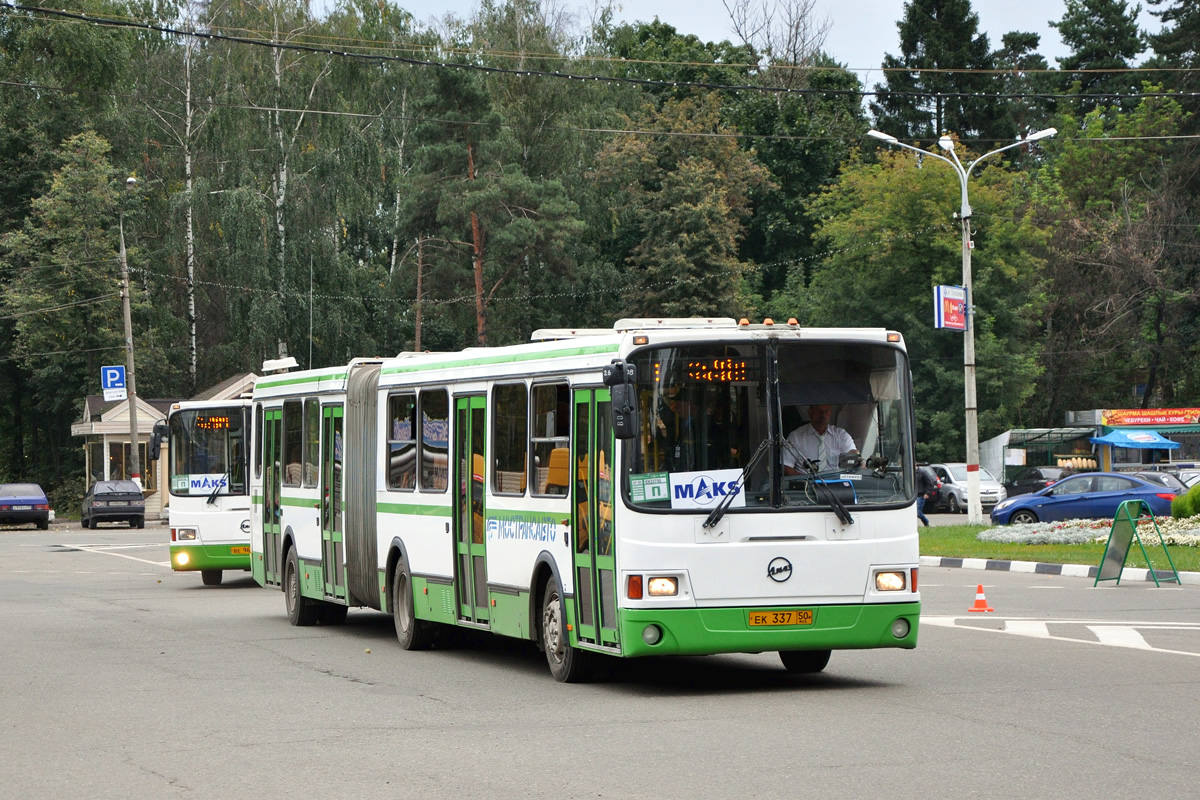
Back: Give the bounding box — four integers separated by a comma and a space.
381, 0, 1159, 84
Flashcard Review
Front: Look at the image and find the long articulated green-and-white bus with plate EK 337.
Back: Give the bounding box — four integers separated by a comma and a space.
251, 319, 920, 681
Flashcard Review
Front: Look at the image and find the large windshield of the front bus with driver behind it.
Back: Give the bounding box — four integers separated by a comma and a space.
625, 341, 913, 511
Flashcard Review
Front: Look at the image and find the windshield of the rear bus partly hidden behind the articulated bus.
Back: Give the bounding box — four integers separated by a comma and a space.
169, 405, 246, 495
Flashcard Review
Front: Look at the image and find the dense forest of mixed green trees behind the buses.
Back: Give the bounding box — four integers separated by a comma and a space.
0, 0, 1200, 503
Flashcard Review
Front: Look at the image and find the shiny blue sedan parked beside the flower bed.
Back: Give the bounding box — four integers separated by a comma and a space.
991, 473, 1175, 525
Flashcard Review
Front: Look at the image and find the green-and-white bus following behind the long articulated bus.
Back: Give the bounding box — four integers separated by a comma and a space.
162, 399, 251, 587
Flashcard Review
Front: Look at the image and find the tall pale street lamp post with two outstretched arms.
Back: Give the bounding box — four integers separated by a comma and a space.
866, 128, 1058, 525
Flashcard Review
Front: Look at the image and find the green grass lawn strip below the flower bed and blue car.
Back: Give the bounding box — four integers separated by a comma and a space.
918, 525, 1200, 572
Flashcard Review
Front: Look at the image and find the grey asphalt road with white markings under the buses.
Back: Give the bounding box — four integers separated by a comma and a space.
0, 525, 1200, 800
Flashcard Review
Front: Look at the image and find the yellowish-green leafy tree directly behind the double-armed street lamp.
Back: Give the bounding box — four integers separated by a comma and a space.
791, 142, 1046, 461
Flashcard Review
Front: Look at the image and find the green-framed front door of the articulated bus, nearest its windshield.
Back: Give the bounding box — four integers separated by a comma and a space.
571, 389, 620, 648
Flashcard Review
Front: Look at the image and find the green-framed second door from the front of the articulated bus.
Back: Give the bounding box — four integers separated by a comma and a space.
454, 395, 490, 625
